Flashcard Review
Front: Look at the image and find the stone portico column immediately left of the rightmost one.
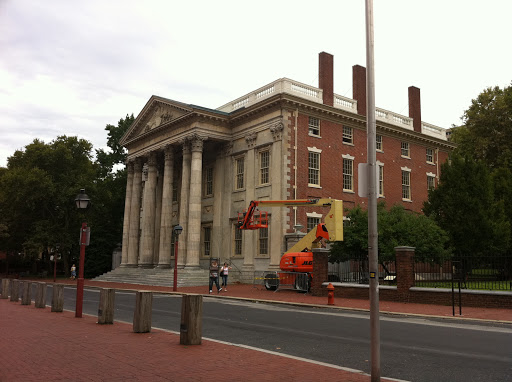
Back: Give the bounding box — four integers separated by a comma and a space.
178, 141, 192, 268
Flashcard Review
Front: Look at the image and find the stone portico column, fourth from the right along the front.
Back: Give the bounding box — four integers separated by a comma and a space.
139, 152, 156, 268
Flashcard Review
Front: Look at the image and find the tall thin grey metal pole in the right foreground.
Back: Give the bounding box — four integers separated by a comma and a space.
366, 0, 380, 382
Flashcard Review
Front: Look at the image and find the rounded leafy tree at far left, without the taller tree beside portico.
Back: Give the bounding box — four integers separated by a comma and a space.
0, 136, 96, 269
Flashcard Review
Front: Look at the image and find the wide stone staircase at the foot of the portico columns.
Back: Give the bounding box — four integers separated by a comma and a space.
93, 267, 209, 287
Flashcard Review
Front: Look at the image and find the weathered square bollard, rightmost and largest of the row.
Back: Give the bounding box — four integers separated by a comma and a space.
180, 295, 203, 345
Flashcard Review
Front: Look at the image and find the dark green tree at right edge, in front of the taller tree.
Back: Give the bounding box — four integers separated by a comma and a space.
423, 153, 510, 257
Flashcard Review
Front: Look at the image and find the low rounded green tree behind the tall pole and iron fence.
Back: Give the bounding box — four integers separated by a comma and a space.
330, 203, 450, 262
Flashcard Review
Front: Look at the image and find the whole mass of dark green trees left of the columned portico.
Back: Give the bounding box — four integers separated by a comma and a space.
0, 115, 135, 277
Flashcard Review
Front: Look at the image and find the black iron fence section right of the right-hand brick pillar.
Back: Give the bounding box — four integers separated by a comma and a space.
414, 256, 512, 291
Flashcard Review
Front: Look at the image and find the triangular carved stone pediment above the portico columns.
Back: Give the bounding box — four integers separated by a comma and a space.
120, 96, 192, 145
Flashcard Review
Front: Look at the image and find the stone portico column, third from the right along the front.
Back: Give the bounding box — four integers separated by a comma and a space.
158, 145, 174, 268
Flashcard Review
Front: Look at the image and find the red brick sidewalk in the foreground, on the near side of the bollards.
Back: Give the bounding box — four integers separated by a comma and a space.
0, 299, 398, 382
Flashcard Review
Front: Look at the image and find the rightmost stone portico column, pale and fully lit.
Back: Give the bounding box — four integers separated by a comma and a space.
186, 136, 203, 268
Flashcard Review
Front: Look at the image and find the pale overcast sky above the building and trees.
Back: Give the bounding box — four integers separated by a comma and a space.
0, 0, 512, 166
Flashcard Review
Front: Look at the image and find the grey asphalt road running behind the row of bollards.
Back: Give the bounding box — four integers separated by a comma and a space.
47, 285, 512, 382
